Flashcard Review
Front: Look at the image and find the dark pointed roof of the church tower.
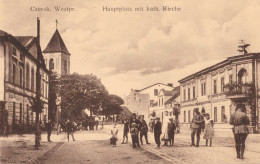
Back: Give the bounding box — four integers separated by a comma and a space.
43, 30, 70, 55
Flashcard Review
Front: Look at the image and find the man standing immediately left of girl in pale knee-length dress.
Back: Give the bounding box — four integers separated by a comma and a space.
191, 108, 204, 147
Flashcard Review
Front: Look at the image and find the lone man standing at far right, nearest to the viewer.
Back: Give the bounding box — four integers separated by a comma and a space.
230, 104, 249, 159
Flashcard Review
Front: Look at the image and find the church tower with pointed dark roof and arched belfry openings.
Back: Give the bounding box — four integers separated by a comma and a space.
43, 29, 70, 75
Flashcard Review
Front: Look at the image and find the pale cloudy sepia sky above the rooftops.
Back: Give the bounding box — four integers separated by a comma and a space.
0, 0, 260, 97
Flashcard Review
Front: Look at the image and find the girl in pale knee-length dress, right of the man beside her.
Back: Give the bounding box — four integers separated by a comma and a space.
203, 113, 214, 147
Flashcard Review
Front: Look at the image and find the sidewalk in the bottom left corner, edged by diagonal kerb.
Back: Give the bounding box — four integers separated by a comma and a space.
0, 132, 66, 164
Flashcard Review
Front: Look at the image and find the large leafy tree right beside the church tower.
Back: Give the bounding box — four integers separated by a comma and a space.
59, 73, 108, 119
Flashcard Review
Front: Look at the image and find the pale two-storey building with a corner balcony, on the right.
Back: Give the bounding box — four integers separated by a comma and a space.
179, 53, 260, 130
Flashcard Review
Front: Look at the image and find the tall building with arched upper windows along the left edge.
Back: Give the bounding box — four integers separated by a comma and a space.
0, 20, 49, 132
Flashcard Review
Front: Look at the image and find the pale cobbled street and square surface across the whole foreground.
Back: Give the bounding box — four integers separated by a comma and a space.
0, 125, 260, 164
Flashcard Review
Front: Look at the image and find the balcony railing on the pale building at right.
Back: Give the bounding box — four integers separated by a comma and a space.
224, 82, 254, 97
